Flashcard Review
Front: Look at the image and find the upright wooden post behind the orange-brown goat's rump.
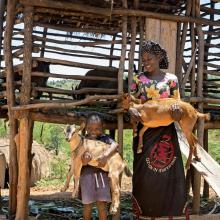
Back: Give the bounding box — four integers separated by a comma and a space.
193, 0, 204, 214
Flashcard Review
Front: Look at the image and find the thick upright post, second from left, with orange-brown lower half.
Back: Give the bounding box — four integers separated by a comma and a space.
16, 6, 33, 220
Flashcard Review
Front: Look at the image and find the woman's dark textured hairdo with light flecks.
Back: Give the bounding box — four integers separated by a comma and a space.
141, 41, 169, 69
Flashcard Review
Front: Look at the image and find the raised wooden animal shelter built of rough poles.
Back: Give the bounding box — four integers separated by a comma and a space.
0, 0, 220, 220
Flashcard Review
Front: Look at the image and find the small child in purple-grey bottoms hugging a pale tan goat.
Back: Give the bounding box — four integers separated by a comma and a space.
80, 114, 118, 220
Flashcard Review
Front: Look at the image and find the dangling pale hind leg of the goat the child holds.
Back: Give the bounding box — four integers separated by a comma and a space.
109, 174, 120, 215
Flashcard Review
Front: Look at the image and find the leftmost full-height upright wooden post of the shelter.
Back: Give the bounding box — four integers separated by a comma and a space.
4, 0, 18, 218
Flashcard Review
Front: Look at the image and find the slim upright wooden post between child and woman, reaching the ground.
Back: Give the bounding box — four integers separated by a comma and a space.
112, 0, 128, 220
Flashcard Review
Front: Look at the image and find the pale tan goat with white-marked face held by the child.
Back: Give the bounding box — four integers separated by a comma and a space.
61, 125, 132, 214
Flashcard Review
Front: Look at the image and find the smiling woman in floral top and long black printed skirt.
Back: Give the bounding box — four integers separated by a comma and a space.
131, 41, 186, 219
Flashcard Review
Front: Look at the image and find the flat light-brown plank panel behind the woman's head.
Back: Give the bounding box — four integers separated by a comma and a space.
145, 18, 177, 74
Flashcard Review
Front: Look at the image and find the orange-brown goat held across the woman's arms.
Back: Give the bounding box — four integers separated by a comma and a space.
122, 94, 210, 169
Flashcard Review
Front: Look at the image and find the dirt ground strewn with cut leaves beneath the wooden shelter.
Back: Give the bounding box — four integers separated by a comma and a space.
0, 175, 220, 220
